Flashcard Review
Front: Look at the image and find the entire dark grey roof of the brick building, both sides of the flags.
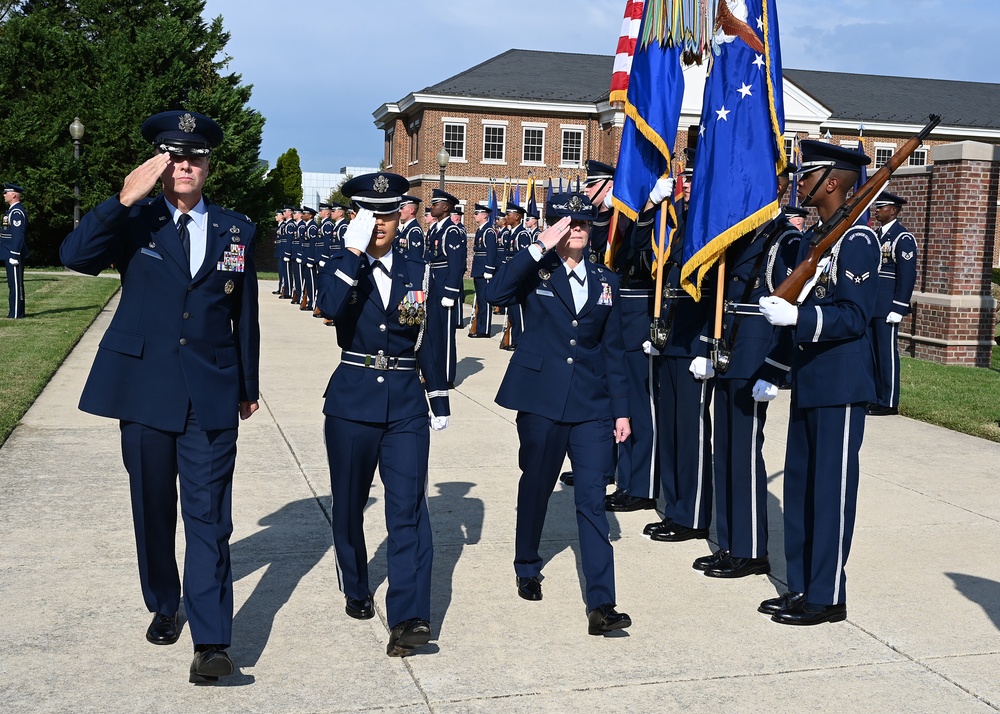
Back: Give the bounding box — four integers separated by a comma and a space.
421, 50, 1000, 129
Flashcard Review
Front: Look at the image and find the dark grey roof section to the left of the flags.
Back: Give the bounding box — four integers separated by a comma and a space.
422, 50, 615, 104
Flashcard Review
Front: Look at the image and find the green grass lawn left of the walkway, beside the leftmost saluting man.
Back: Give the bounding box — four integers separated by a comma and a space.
0, 272, 121, 444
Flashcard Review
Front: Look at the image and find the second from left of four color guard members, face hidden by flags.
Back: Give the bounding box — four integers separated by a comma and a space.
643, 149, 718, 542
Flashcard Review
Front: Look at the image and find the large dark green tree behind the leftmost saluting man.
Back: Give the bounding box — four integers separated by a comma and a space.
0, 0, 272, 264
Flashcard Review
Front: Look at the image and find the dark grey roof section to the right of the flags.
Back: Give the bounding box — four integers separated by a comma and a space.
782, 67, 1000, 129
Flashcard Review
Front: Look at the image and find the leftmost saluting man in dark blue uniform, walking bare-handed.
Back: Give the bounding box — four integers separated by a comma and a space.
59, 111, 260, 683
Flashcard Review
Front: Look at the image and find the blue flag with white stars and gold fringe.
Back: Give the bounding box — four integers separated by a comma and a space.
681, 0, 786, 300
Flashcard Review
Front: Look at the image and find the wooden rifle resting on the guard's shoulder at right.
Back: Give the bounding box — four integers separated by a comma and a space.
772, 114, 941, 304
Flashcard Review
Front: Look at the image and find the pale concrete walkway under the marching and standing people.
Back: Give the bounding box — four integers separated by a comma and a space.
0, 278, 1000, 712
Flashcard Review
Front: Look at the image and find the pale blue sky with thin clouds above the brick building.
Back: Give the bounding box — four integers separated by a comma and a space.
199, 0, 1000, 172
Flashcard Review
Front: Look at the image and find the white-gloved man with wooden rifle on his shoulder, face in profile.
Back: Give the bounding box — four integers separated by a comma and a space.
759, 140, 880, 625
